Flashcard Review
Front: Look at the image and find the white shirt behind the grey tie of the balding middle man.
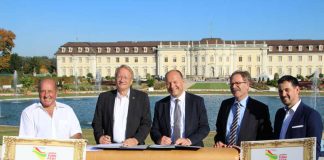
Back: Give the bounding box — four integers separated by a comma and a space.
170, 92, 186, 139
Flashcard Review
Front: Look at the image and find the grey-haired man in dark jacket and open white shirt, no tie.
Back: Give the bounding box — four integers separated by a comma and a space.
92, 65, 152, 146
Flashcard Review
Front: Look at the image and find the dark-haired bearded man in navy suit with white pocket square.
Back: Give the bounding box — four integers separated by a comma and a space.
274, 75, 323, 158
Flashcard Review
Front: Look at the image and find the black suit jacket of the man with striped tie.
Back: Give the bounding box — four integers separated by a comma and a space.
214, 97, 273, 146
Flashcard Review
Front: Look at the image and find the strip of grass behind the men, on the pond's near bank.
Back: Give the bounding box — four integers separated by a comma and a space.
0, 126, 215, 147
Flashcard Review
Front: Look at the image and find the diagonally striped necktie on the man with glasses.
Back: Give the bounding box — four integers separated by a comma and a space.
228, 103, 241, 145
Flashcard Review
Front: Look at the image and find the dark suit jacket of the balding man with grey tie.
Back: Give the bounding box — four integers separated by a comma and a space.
151, 92, 209, 146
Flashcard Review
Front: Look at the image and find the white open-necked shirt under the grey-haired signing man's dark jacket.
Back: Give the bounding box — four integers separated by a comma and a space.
113, 90, 130, 143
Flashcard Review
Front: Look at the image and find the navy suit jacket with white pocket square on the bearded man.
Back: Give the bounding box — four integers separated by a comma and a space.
274, 102, 323, 158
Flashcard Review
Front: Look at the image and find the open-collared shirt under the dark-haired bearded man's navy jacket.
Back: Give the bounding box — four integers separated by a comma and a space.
279, 99, 301, 139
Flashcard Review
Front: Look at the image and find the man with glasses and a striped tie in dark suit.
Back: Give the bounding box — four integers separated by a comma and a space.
214, 71, 273, 147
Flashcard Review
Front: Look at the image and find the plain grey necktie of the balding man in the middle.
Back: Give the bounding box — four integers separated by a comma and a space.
173, 99, 181, 143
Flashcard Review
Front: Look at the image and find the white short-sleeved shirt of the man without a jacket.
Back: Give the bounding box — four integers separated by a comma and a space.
19, 102, 82, 139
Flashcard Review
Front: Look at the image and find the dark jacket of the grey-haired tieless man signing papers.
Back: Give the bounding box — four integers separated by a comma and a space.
92, 89, 152, 144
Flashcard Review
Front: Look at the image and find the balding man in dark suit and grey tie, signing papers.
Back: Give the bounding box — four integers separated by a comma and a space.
151, 70, 209, 146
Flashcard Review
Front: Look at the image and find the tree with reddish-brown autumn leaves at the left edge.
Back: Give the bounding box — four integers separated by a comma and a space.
0, 28, 16, 72
